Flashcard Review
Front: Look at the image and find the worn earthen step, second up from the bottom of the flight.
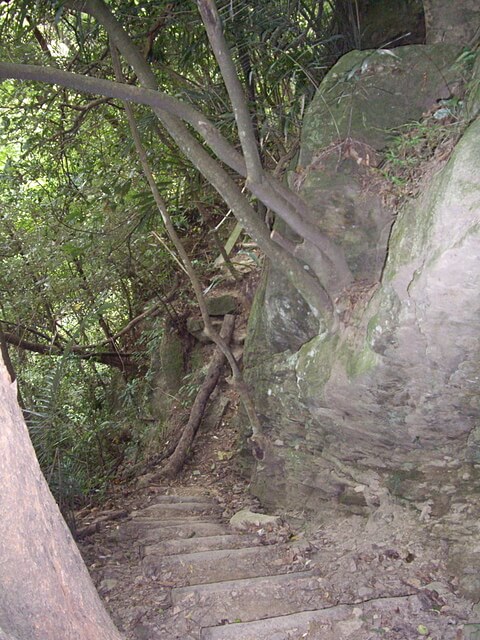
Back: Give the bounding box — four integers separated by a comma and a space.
172, 571, 332, 627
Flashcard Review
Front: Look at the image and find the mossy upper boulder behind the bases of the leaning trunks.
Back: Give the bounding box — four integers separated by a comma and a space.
245, 45, 459, 362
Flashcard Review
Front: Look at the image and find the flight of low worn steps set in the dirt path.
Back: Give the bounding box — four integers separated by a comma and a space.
82, 495, 472, 640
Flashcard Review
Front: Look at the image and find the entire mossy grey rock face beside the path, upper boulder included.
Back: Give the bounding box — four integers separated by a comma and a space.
245, 45, 480, 597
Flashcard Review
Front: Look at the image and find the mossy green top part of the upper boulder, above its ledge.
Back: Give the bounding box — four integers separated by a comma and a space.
299, 44, 461, 162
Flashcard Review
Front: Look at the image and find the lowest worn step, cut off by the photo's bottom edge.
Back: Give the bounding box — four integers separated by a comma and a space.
200, 595, 428, 640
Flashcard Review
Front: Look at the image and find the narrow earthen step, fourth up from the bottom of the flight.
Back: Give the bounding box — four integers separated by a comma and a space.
109, 518, 229, 544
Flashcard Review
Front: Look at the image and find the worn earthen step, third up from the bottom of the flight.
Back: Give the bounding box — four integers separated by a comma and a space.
143, 545, 308, 586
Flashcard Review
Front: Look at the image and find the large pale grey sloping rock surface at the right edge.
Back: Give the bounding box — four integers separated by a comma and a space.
249, 116, 480, 501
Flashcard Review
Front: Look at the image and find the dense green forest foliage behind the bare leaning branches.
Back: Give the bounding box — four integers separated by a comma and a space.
0, 0, 362, 510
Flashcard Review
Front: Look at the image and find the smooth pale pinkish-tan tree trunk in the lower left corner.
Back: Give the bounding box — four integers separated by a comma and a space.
0, 362, 122, 640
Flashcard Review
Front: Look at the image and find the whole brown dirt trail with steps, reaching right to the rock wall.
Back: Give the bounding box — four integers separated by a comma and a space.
80, 476, 471, 640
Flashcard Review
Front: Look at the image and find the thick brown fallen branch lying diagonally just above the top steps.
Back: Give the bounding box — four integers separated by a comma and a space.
159, 315, 235, 478
